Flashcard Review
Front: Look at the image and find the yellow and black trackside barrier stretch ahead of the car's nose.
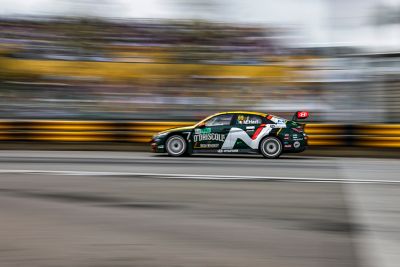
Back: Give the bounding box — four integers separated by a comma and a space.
0, 120, 193, 143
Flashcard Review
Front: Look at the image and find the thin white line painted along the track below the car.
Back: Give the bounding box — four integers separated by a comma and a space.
0, 169, 400, 184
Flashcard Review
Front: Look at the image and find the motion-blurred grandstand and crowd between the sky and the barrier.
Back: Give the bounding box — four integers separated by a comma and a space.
0, 17, 400, 122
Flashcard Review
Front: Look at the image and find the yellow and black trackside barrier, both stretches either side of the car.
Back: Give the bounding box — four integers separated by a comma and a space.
0, 120, 400, 148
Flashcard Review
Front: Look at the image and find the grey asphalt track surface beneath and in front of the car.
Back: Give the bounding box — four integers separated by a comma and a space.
0, 151, 400, 267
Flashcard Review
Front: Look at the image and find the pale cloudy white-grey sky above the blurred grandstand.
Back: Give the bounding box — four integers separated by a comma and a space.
0, 0, 400, 50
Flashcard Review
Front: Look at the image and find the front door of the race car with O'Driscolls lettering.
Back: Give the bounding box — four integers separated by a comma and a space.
192, 114, 233, 152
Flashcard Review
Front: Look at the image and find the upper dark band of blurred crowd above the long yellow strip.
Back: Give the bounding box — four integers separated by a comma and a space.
0, 18, 284, 65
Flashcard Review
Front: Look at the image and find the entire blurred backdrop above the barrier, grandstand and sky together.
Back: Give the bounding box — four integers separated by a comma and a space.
0, 0, 400, 124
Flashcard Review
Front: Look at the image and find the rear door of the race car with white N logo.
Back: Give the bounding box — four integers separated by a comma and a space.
224, 113, 266, 150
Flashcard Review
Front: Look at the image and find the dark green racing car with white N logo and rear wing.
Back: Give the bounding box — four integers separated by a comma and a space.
151, 111, 309, 159
